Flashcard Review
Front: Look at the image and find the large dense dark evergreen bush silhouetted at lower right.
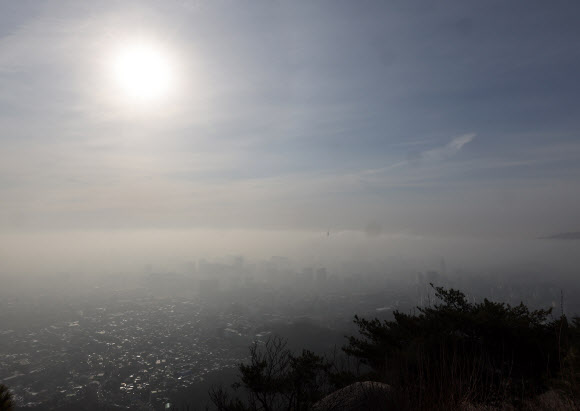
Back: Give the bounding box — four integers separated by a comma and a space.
344, 285, 569, 408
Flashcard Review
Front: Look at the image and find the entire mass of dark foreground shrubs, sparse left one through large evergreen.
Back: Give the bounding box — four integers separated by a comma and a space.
210, 284, 580, 411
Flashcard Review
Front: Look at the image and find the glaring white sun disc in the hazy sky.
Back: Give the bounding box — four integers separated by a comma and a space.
113, 44, 172, 102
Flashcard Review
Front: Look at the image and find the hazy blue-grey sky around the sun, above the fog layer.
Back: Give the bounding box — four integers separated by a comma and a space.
0, 0, 580, 245
